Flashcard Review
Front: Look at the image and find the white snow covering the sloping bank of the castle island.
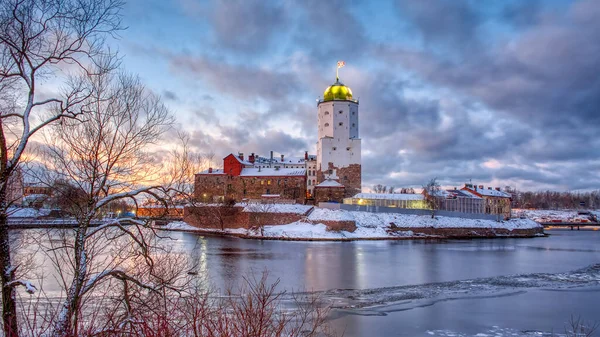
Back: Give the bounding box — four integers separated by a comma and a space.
163, 205, 540, 240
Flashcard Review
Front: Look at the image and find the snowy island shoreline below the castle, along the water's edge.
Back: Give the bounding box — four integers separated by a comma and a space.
158, 207, 544, 241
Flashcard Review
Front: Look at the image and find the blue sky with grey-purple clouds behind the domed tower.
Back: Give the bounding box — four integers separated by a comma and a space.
112, 0, 600, 191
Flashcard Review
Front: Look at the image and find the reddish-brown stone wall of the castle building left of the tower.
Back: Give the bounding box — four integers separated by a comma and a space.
194, 174, 306, 203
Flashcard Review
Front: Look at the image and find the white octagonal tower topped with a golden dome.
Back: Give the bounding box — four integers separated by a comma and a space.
317, 72, 361, 196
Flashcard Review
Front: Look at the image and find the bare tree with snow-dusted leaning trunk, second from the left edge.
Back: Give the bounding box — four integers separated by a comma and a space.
38, 69, 172, 336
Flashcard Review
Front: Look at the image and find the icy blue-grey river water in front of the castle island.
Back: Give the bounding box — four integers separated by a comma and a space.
19, 230, 600, 337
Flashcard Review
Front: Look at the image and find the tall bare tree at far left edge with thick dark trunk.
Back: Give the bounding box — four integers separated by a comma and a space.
0, 0, 123, 330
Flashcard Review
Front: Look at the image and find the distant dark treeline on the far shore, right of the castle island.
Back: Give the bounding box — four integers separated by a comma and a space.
507, 190, 600, 209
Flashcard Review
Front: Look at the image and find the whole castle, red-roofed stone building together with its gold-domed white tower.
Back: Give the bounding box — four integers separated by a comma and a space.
194, 63, 362, 203
